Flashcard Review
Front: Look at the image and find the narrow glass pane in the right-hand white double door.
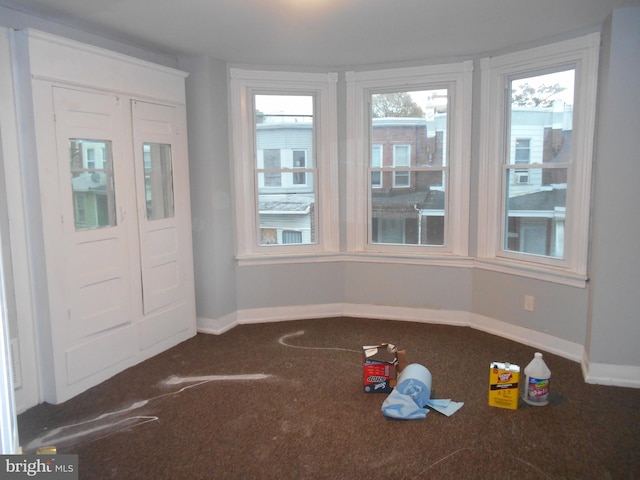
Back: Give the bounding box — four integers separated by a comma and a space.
142, 143, 174, 220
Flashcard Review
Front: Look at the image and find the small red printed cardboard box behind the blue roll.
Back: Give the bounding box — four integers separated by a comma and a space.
362, 343, 398, 393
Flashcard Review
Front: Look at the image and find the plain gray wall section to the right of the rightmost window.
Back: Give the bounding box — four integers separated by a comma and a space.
586, 7, 640, 366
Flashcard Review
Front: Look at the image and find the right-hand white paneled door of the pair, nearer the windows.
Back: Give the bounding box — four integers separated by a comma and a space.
131, 100, 195, 351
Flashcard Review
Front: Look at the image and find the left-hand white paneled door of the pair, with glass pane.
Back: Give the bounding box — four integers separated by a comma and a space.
53, 87, 132, 348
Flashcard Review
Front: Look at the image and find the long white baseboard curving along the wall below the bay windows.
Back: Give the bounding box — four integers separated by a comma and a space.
198, 303, 640, 388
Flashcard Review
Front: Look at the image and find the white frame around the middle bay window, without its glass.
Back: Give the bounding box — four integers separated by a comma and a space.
346, 61, 473, 260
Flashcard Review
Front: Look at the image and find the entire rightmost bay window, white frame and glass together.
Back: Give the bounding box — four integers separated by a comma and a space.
478, 34, 599, 285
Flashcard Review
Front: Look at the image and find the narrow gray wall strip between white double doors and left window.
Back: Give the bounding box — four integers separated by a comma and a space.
179, 56, 237, 319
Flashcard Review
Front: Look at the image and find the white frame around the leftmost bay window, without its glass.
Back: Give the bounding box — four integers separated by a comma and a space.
229, 68, 339, 264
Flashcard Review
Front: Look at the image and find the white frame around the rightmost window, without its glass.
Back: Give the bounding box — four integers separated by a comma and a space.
477, 33, 600, 287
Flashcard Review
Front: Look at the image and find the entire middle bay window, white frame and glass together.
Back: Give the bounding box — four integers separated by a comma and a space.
346, 62, 473, 255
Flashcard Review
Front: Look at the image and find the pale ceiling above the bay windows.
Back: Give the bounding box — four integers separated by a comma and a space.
0, 0, 640, 68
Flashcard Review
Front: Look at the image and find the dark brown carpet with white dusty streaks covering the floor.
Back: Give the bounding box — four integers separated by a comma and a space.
18, 318, 640, 480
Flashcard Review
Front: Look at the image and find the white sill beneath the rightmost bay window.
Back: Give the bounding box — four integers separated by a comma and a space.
474, 258, 589, 288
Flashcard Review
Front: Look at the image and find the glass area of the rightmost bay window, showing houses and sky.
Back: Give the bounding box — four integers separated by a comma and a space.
504, 69, 575, 258
